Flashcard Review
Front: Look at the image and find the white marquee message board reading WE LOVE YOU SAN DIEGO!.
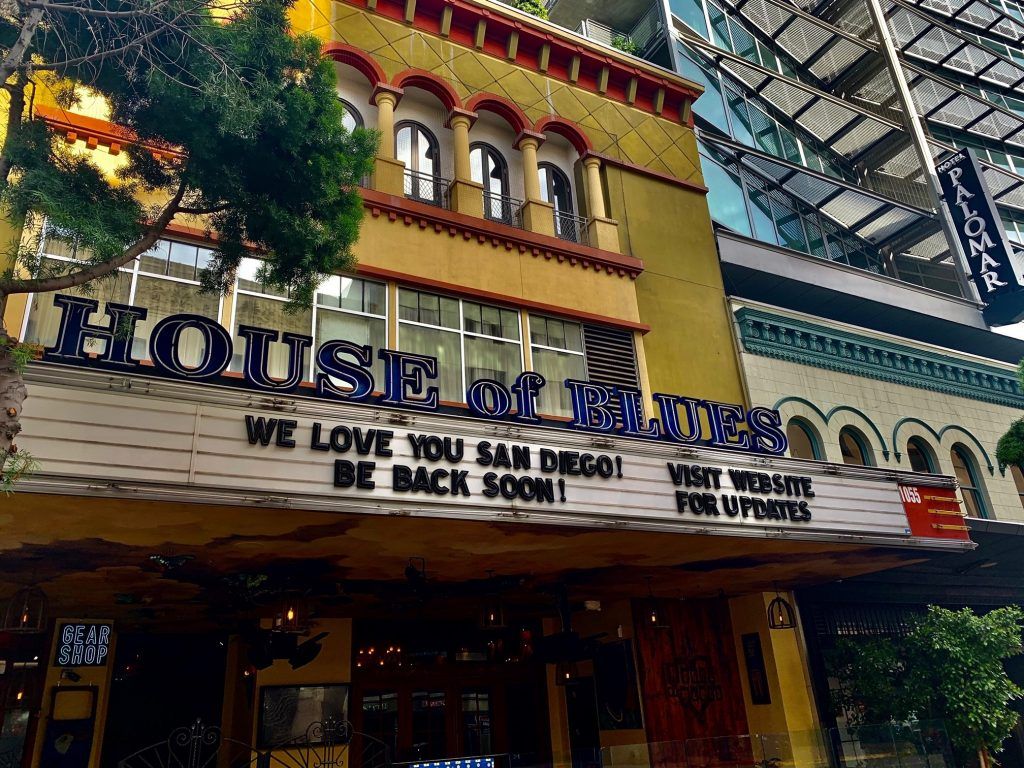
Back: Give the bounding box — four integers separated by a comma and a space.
25, 367, 963, 548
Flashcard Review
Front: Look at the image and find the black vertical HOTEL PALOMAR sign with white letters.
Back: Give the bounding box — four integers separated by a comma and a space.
935, 150, 1021, 303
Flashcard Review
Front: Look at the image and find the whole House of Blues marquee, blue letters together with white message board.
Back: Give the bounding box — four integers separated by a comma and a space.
24, 296, 965, 552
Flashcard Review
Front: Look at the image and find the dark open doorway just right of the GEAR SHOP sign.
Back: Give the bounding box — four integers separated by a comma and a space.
101, 634, 227, 768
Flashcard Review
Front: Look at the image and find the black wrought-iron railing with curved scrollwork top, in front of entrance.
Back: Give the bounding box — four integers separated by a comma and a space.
117, 720, 391, 768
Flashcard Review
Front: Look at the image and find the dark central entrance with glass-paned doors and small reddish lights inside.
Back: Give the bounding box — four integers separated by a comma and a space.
352, 623, 550, 768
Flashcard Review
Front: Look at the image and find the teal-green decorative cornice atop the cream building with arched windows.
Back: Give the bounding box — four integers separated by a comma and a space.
736, 307, 1024, 409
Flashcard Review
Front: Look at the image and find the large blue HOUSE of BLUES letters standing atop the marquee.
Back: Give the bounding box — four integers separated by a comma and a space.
39, 295, 787, 455
